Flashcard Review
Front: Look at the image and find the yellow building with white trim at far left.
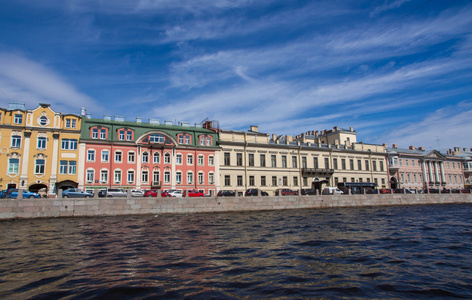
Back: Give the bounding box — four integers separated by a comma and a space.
0, 103, 81, 194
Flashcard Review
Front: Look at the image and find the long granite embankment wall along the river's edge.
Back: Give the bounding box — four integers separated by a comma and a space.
0, 194, 472, 220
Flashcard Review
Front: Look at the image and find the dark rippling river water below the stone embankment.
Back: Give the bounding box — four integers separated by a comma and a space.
0, 204, 472, 299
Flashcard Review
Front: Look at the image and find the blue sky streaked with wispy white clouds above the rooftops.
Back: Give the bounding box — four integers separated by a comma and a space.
0, 0, 472, 150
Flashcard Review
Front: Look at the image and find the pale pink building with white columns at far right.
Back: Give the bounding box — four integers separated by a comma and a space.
386, 144, 472, 190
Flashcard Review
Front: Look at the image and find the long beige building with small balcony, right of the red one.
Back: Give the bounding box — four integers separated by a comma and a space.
219, 126, 388, 195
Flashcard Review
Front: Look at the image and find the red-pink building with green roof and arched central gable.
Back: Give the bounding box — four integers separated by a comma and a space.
79, 115, 219, 194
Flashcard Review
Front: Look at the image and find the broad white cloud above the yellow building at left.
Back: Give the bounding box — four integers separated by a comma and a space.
0, 53, 101, 113
